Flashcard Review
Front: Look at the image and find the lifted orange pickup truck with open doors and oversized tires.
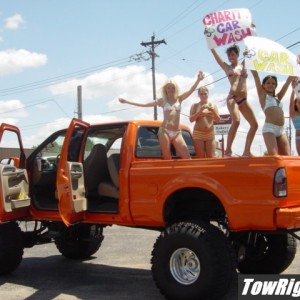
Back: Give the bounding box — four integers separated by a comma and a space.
0, 119, 300, 300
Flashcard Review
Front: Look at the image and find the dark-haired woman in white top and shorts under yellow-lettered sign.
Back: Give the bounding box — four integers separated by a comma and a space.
251, 70, 294, 155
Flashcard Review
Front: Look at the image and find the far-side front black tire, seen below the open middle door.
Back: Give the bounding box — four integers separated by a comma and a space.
55, 224, 103, 259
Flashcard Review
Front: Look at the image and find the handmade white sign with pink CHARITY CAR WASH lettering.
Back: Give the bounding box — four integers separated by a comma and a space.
203, 8, 255, 49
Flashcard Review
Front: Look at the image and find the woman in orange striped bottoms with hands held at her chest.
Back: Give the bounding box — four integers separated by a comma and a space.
190, 86, 220, 158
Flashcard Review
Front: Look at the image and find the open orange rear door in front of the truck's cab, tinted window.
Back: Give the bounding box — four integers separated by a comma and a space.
56, 119, 89, 225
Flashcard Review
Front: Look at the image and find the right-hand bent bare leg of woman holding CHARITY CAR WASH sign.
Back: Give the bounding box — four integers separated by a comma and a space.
239, 101, 258, 156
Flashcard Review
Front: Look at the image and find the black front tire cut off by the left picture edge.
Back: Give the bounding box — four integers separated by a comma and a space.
0, 222, 24, 275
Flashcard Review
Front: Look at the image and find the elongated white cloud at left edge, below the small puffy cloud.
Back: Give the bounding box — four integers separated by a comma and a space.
0, 49, 47, 75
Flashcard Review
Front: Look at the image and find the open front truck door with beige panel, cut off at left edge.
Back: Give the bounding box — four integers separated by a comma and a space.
0, 123, 30, 222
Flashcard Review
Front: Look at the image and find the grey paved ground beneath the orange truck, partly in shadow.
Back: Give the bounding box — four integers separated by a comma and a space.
0, 226, 300, 300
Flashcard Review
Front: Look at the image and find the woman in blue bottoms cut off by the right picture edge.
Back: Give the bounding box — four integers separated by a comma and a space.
290, 79, 300, 155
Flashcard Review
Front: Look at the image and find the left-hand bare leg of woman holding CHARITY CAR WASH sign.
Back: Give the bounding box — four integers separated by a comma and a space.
225, 99, 240, 155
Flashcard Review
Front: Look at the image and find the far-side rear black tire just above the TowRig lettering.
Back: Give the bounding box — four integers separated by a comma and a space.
237, 233, 297, 274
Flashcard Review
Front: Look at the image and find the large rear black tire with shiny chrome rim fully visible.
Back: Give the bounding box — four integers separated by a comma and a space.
151, 222, 235, 300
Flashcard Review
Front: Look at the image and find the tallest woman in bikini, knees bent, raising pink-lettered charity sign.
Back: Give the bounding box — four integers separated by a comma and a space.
211, 45, 258, 157
